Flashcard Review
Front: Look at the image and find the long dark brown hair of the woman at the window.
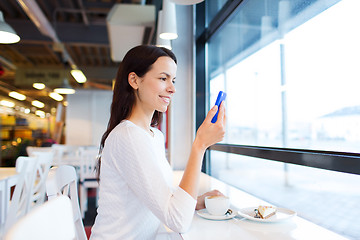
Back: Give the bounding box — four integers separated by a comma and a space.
97, 45, 177, 178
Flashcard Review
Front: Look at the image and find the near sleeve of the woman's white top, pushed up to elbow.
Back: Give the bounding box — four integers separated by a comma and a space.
113, 126, 196, 232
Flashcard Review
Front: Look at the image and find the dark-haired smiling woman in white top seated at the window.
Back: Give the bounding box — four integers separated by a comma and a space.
91, 46, 225, 240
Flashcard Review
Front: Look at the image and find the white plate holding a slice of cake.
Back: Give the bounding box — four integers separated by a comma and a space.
238, 207, 296, 222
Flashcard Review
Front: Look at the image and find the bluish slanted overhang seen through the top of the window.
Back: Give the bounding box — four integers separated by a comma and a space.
206, 0, 339, 78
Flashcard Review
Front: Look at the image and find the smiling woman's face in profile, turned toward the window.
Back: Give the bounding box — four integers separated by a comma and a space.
137, 57, 177, 112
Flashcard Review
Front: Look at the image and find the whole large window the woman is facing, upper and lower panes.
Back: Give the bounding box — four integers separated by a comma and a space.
198, 0, 360, 239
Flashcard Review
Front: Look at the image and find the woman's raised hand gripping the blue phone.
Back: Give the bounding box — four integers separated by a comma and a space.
194, 102, 226, 150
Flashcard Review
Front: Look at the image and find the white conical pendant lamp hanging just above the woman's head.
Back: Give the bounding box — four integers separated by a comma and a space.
159, 0, 178, 40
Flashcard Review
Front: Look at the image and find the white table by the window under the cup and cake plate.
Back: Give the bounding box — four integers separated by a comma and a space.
174, 171, 346, 240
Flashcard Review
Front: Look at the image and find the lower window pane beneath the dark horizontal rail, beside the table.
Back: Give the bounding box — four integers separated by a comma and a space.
211, 151, 360, 239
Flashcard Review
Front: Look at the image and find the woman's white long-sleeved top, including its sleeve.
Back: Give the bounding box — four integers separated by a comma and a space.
90, 120, 196, 240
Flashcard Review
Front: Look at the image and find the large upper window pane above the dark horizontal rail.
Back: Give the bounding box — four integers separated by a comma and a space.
208, 0, 360, 152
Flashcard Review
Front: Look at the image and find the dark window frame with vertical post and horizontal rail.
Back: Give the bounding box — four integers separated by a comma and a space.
195, 0, 360, 175
